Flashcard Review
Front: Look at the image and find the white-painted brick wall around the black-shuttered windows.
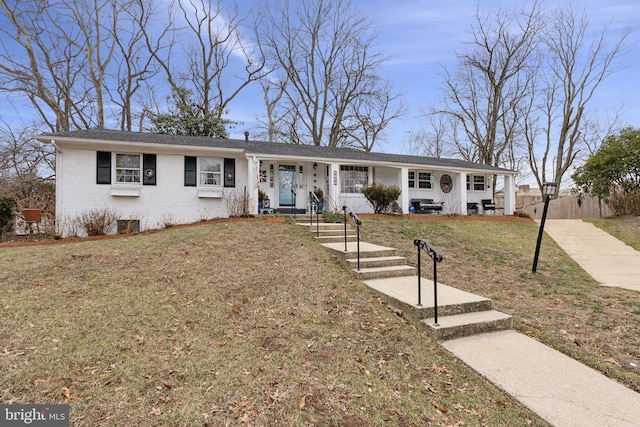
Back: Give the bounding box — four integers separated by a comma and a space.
56, 147, 248, 237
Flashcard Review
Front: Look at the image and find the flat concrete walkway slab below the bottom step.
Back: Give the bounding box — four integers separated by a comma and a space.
442, 331, 640, 427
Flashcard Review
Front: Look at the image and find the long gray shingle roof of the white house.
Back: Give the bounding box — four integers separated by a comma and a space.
37, 129, 516, 174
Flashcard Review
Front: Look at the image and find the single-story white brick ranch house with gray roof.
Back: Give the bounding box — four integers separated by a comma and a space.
37, 129, 517, 236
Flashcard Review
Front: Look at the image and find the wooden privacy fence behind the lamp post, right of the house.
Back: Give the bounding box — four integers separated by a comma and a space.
517, 195, 613, 219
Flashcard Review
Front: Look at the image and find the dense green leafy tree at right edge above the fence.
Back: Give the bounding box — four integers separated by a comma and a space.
571, 127, 640, 203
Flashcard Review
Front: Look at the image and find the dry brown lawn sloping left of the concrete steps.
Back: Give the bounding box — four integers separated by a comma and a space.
0, 218, 546, 426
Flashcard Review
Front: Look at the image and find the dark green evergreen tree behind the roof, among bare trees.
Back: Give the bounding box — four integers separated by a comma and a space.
151, 88, 235, 138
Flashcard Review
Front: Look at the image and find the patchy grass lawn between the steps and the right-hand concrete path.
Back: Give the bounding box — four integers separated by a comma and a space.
361, 215, 640, 392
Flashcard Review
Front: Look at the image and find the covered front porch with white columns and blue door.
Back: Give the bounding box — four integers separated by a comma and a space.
249, 157, 516, 215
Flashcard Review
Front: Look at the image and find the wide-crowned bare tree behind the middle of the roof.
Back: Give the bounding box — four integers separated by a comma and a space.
256, 0, 396, 149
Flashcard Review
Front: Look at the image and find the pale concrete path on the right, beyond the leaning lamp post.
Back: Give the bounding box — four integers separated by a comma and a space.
543, 219, 640, 292
